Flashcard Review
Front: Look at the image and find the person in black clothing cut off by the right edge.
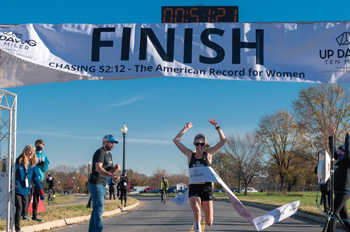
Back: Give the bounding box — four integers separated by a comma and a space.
329, 127, 350, 231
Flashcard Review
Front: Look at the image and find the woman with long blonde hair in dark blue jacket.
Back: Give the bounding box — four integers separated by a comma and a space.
15, 145, 45, 232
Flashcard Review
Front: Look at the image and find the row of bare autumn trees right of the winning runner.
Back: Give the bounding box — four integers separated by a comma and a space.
213, 84, 350, 192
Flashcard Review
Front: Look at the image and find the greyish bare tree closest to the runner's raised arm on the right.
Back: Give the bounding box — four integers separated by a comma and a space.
224, 133, 264, 195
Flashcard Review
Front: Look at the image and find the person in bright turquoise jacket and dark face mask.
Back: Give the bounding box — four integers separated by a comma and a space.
22, 139, 50, 222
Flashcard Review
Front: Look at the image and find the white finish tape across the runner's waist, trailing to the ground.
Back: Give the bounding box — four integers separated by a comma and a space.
174, 167, 300, 231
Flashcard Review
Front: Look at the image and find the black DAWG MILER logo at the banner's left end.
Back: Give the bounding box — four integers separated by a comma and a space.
0, 31, 37, 50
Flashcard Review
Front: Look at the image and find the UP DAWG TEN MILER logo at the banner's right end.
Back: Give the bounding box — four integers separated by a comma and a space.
320, 32, 350, 64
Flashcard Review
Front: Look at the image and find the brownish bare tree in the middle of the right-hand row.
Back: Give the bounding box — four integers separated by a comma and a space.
257, 110, 301, 191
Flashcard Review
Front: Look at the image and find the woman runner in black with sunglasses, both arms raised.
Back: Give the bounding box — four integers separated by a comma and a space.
173, 119, 226, 232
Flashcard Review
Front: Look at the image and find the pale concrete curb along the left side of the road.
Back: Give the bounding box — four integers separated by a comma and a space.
1, 201, 140, 232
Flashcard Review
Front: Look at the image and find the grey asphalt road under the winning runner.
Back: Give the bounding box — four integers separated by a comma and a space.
56, 196, 323, 232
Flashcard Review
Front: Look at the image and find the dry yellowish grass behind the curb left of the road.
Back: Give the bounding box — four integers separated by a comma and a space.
0, 195, 137, 230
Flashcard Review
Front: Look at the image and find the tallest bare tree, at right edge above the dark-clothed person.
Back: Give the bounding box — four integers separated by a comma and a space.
292, 84, 350, 154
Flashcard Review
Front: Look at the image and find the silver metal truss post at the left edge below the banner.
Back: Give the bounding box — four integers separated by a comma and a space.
0, 89, 17, 231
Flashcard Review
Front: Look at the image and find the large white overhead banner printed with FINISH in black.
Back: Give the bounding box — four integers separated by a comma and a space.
0, 22, 350, 88
